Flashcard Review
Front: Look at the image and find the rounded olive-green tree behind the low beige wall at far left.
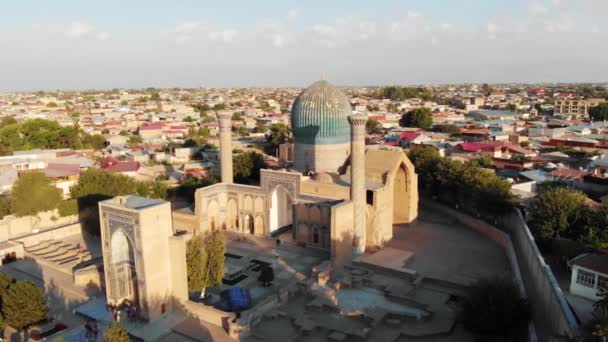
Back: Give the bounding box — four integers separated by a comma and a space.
11, 172, 61, 216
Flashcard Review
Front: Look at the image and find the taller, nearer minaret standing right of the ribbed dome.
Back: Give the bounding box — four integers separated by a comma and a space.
348, 114, 367, 256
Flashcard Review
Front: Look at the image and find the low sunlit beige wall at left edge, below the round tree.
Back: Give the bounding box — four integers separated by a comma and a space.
0, 210, 78, 241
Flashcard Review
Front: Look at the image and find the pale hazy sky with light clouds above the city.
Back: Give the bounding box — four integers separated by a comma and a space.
0, 0, 608, 91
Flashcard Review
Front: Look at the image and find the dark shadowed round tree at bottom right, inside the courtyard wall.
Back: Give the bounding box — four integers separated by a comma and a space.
461, 278, 530, 341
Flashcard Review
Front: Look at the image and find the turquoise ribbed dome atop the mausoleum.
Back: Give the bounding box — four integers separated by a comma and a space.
291, 80, 352, 144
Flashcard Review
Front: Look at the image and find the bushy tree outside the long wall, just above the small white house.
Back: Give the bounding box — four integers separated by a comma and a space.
529, 185, 593, 241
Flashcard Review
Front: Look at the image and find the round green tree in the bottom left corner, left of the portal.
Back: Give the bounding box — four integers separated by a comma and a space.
2, 281, 48, 331
